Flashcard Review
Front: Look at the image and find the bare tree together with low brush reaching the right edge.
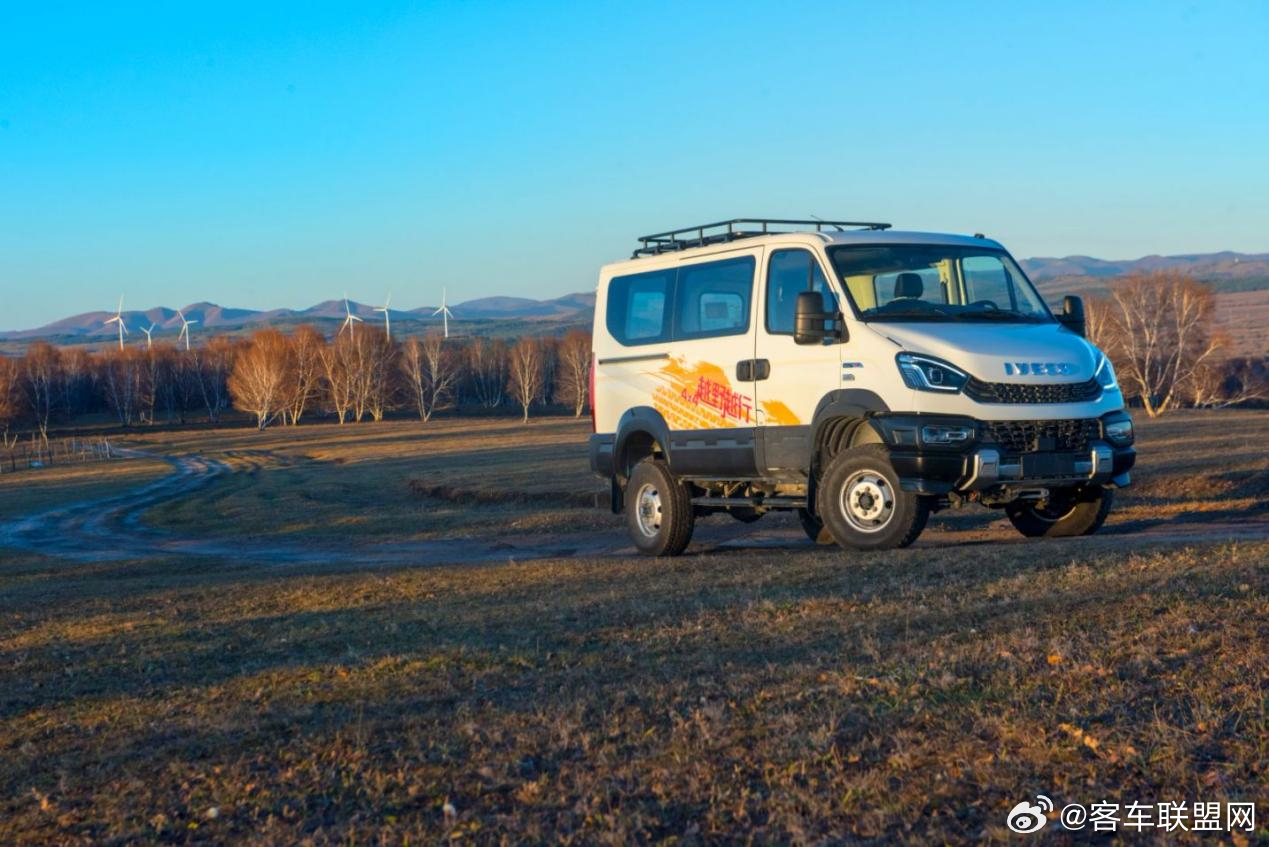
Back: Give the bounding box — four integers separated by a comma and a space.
1085, 270, 1269, 418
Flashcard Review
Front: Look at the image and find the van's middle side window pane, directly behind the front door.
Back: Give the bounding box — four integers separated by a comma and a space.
674, 257, 755, 339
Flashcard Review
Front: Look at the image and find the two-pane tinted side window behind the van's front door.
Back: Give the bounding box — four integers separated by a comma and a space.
607, 257, 756, 347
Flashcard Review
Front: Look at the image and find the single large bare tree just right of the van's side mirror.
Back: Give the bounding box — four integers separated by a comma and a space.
1107, 270, 1220, 418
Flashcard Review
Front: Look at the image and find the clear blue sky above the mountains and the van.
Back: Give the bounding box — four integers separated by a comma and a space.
0, 0, 1269, 329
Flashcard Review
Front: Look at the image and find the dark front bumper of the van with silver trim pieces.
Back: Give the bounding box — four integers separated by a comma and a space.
873, 413, 1137, 494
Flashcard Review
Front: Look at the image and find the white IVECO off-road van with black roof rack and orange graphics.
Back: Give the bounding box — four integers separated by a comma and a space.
590, 218, 1136, 555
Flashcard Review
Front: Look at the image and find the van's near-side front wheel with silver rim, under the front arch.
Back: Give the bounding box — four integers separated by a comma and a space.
816, 444, 930, 550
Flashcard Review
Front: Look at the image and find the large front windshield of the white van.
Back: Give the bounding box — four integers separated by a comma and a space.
829, 244, 1053, 323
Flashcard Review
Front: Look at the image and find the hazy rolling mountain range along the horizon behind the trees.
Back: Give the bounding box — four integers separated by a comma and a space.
0, 250, 1269, 354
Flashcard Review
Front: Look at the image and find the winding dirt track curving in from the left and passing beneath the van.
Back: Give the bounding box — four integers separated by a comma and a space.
0, 451, 1269, 566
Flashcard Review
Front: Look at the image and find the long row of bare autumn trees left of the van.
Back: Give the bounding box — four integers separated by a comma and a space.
0, 326, 590, 438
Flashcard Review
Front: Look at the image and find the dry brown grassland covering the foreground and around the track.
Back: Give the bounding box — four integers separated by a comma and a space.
0, 413, 1269, 844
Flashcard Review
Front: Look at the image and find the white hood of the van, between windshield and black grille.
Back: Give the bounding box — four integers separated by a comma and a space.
867, 321, 1098, 383
